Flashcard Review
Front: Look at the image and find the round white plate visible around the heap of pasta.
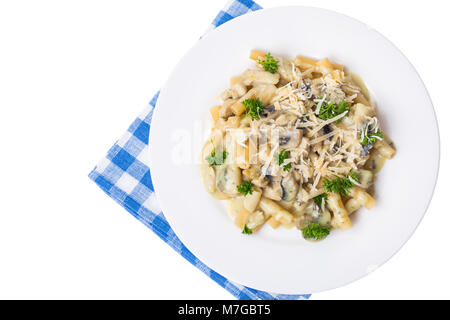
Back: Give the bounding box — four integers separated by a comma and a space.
150, 7, 439, 294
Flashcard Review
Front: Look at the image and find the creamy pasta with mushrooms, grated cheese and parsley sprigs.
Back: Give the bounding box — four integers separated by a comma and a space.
200, 50, 396, 241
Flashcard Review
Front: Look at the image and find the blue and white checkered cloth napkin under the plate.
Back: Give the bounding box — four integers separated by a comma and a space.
89, 0, 310, 300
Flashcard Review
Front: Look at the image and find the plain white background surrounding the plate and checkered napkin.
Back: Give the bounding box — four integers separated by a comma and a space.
0, 0, 450, 299
